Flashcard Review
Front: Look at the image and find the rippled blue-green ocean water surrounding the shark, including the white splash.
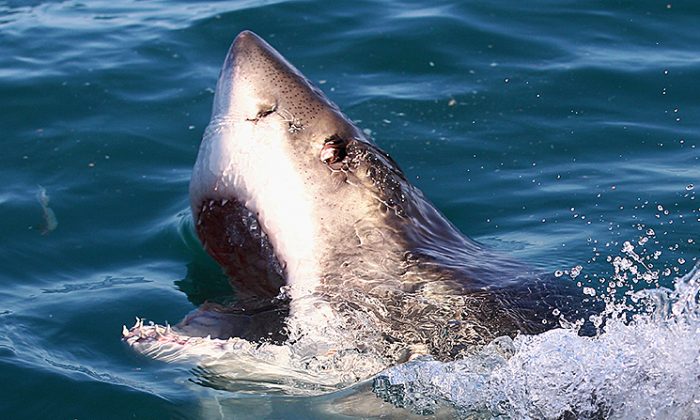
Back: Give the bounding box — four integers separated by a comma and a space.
0, 0, 700, 419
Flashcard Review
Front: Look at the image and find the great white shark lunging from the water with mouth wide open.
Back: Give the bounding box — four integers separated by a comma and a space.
124, 31, 591, 363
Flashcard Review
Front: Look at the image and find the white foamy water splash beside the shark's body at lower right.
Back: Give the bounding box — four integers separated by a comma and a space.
375, 265, 700, 419
